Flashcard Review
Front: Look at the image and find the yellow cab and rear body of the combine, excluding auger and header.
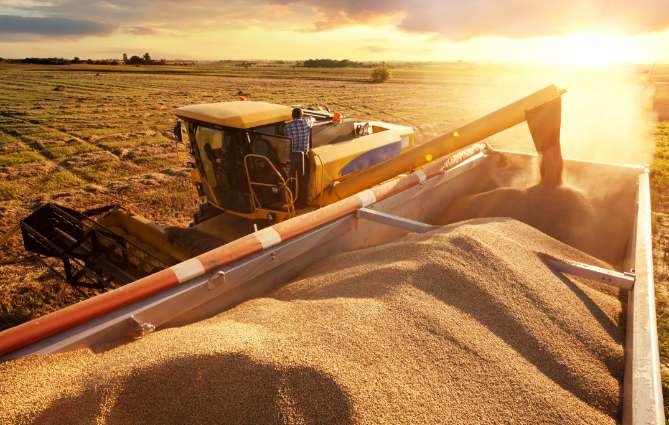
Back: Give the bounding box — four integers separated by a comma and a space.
176, 101, 414, 223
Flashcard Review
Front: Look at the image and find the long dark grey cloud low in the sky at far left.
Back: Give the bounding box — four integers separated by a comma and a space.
0, 15, 114, 37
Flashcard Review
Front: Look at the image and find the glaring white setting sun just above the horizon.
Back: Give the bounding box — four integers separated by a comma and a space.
551, 32, 640, 66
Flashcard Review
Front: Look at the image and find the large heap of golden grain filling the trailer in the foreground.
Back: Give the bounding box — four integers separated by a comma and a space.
0, 219, 624, 424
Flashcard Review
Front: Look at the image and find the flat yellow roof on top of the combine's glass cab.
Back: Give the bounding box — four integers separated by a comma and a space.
174, 101, 292, 129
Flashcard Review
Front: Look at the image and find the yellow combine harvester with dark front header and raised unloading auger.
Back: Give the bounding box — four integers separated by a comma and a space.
21, 86, 562, 285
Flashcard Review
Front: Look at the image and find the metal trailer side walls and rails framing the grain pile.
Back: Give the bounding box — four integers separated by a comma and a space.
0, 148, 664, 425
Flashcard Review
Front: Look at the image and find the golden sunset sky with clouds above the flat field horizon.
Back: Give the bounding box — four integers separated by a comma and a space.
0, 0, 669, 65
